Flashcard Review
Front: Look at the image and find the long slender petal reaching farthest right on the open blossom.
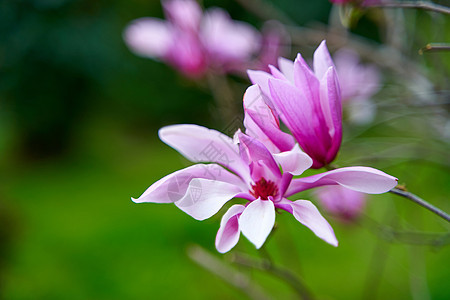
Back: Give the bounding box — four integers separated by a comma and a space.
285, 167, 397, 197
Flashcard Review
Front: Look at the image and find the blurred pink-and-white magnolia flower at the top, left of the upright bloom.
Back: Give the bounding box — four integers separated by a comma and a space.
124, 0, 260, 77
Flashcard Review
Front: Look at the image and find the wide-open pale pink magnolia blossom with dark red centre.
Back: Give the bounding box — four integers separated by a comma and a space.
133, 86, 397, 253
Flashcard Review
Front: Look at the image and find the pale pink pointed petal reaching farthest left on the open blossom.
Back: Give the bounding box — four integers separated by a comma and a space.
131, 164, 246, 203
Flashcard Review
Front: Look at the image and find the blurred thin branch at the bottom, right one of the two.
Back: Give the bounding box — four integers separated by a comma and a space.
231, 253, 314, 300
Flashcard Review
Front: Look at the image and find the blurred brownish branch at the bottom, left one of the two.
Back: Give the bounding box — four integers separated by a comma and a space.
187, 245, 270, 300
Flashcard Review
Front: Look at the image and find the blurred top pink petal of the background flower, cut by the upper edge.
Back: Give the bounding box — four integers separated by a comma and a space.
162, 0, 202, 32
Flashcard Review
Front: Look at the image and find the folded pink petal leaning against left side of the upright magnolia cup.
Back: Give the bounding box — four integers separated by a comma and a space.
244, 85, 295, 153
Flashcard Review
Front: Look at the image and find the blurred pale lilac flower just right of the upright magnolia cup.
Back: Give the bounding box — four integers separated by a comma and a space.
333, 49, 380, 124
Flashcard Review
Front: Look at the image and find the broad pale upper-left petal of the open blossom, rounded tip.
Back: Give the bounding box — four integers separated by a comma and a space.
159, 124, 250, 182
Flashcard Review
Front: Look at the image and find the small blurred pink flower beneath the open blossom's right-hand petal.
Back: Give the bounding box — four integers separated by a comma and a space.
315, 185, 366, 221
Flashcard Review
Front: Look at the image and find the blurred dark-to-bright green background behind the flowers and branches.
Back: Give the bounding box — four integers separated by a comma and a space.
0, 0, 450, 299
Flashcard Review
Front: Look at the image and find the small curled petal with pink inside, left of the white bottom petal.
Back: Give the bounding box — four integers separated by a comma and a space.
216, 204, 245, 253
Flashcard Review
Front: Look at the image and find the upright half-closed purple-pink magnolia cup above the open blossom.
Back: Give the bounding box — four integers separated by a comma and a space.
248, 41, 342, 168
